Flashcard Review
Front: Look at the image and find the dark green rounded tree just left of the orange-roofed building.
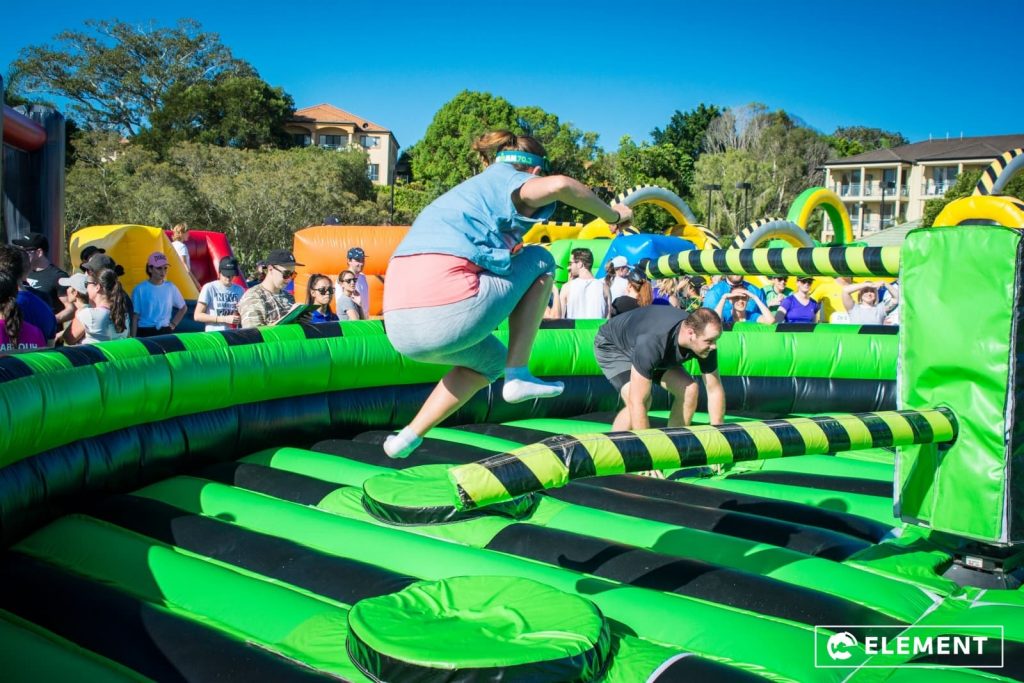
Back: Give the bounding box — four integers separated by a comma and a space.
135, 76, 295, 153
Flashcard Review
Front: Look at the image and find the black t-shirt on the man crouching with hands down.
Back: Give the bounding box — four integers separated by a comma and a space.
597, 306, 718, 379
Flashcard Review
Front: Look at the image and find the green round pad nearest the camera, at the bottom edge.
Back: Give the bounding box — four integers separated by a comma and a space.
345, 577, 611, 683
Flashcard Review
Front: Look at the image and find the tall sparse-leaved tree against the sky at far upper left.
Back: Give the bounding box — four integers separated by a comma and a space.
11, 19, 256, 135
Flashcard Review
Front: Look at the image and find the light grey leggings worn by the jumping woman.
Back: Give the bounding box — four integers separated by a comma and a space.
384, 245, 555, 382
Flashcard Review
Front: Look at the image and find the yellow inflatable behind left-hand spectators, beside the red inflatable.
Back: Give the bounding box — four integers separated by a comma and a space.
69, 225, 199, 299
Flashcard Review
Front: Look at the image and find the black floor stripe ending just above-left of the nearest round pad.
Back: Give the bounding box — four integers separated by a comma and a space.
88, 496, 419, 605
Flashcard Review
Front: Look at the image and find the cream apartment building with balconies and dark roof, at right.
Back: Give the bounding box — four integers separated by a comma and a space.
822, 134, 1024, 241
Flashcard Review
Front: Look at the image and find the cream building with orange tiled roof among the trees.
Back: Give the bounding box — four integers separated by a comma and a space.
286, 104, 398, 185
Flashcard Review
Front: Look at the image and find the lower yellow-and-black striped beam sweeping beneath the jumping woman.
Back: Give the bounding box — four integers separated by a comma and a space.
449, 408, 957, 510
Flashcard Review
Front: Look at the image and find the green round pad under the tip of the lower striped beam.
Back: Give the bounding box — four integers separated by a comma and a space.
362, 465, 537, 524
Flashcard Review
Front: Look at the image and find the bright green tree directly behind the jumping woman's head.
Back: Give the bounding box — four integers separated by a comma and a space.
410, 90, 597, 197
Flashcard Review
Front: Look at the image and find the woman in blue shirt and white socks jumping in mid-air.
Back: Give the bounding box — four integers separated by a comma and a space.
384, 130, 633, 458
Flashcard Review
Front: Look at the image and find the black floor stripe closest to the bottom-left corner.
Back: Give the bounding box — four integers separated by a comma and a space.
0, 553, 327, 683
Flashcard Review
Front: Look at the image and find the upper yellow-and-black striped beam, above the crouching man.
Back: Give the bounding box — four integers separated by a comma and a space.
647, 247, 899, 278
